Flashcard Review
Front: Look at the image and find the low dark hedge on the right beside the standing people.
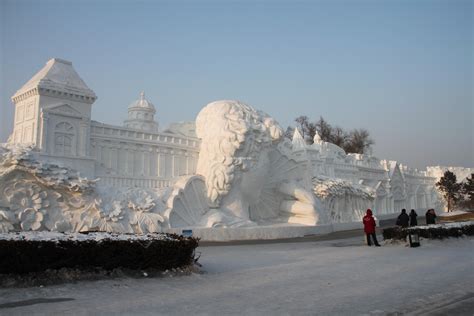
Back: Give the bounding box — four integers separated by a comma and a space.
382, 224, 474, 240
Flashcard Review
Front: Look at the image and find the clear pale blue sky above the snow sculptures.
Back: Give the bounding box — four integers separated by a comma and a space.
0, 0, 474, 167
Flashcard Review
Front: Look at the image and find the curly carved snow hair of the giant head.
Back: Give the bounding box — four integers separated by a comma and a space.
196, 100, 283, 204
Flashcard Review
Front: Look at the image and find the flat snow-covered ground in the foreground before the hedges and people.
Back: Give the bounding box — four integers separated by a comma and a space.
0, 236, 474, 315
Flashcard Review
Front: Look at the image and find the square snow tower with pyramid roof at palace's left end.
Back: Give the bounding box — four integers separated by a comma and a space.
10, 58, 97, 159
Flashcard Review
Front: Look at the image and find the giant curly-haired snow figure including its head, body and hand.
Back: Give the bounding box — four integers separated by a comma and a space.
196, 101, 319, 226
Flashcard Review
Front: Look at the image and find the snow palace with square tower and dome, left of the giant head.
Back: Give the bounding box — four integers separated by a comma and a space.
10, 58, 199, 188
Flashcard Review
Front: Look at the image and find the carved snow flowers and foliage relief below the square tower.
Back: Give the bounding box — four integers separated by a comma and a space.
0, 145, 166, 233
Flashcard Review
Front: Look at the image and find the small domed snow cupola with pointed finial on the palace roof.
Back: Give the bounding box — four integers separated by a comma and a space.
124, 92, 158, 132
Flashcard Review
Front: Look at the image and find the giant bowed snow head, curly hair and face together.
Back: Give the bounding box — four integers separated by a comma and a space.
196, 100, 283, 218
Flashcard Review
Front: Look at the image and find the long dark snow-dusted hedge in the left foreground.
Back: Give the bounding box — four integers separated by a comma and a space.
0, 233, 199, 274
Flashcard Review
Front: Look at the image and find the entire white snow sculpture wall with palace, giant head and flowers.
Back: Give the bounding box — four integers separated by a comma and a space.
5, 58, 474, 236
